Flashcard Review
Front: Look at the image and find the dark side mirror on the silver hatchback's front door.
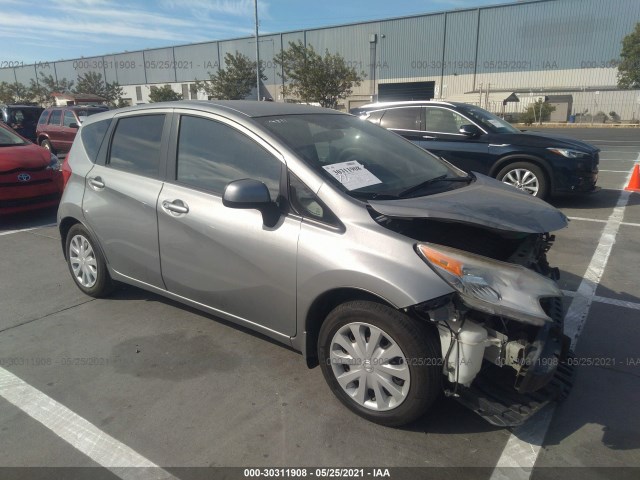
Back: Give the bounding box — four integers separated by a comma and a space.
222, 178, 280, 227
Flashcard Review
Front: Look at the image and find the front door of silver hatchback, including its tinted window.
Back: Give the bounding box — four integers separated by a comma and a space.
157, 111, 301, 336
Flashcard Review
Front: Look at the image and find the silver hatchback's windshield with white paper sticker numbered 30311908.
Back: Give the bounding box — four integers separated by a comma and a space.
255, 114, 464, 199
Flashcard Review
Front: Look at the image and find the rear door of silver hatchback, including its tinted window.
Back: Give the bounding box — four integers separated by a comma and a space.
83, 110, 171, 288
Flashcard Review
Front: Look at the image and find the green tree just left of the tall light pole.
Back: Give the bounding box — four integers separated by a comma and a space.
196, 51, 267, 100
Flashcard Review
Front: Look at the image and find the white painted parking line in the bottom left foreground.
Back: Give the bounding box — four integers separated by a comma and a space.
0, 368, 176, 480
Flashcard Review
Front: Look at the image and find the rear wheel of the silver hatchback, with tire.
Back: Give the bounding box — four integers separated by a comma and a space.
65, 224, 114, 298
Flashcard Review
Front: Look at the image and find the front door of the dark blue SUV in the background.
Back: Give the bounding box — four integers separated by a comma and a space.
415, 106, 494, 173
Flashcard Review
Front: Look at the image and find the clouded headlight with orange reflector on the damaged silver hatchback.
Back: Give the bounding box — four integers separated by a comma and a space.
416, 243, 562, 326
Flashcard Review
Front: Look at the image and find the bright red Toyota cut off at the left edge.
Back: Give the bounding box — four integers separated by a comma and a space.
0, 122, 64, 215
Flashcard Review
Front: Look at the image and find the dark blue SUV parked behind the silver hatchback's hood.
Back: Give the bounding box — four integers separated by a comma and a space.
351, 101, 600, 198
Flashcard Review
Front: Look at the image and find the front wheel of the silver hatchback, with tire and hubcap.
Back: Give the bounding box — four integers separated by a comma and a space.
318, 301, 442, 427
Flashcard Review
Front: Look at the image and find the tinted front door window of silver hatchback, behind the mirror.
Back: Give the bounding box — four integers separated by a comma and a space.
177, 116, 282, 200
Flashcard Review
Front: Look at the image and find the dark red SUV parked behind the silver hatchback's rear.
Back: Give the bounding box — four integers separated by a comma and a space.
36, 105, 109, 153
